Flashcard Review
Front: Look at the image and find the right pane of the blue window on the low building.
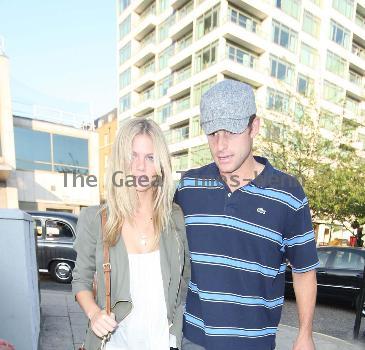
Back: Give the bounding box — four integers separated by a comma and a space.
53, 134, 89, 172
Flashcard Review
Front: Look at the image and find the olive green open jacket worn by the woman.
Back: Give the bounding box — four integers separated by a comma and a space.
72, 203, 190, 350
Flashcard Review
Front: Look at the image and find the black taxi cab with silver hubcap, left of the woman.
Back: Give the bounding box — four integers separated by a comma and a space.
28, 211, 77, 283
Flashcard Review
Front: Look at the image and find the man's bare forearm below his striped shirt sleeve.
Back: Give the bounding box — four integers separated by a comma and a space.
293, 270, 317, 350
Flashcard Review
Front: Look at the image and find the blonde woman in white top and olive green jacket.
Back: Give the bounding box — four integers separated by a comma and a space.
72, 118, 190, 350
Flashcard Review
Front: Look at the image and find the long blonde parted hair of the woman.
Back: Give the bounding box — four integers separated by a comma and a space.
99, 117, 174, 247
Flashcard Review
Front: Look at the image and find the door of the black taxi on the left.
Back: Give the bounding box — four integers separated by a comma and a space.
44, 218, 75, 266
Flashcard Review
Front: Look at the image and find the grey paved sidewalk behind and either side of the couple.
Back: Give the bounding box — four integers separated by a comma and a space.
39, 290, 364, 350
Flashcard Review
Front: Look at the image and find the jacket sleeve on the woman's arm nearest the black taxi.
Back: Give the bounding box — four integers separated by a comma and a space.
72, 208, 97, 299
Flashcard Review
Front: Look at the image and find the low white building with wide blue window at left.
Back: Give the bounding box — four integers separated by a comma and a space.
0, 45, 100, 214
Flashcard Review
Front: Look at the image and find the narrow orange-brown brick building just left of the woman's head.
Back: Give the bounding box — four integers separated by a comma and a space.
94, 108, 118, 201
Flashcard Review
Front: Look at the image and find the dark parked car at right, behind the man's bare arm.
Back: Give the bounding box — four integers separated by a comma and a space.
285, 246, 365, 306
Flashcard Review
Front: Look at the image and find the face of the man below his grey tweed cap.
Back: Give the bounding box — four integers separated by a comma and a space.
207, 117, 259, 176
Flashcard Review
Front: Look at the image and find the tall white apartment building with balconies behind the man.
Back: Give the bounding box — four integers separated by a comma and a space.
118, 0, 365, 178
